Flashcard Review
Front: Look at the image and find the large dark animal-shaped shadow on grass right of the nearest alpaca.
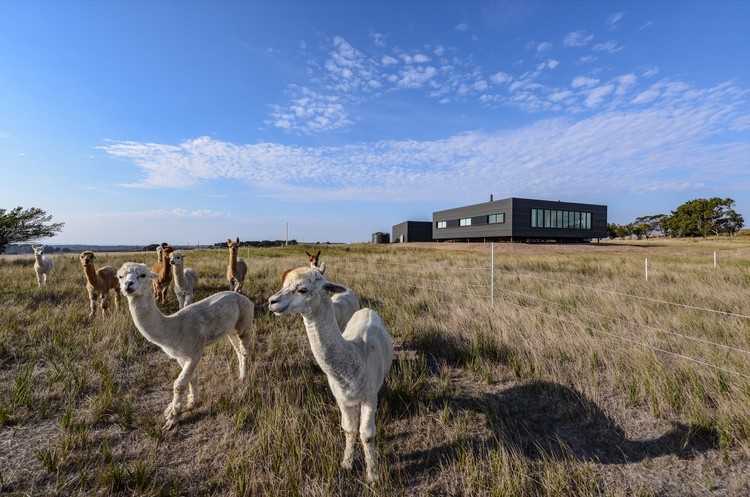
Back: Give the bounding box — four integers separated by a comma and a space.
402, 381, 718, 474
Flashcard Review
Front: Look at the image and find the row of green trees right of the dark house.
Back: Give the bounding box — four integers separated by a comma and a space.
607, 197, 745, 240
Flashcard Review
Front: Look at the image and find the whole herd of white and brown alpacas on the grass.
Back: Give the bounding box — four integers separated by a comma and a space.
32, 237, 393, 481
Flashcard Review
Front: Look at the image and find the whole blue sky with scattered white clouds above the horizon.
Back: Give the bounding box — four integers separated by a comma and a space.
0, 1, 750, 244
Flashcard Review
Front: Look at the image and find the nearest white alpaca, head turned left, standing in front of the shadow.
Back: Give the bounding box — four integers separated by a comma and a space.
268, 267, 393, 481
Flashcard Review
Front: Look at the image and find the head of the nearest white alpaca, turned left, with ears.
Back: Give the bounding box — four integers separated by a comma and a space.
268, 267, 346, 316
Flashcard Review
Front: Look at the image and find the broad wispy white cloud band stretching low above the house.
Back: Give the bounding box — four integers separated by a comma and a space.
99, 81, 750, 203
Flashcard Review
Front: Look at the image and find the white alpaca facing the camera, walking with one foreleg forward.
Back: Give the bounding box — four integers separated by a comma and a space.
117, 262, 255, 430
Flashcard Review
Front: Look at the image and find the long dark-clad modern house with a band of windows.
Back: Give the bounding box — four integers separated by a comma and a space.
432, 198, 607, 242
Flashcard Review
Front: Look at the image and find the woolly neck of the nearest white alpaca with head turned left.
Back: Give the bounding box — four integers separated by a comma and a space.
302, 293, 364, 385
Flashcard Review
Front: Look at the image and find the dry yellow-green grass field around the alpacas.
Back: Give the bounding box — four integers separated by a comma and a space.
0, 237, 750, 496
